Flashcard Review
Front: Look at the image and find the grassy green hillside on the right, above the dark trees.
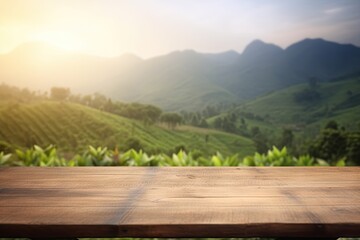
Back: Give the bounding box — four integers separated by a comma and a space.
208, 74, 360, 137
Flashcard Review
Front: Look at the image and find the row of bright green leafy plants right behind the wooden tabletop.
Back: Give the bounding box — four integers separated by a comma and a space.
0, 145, 346, 167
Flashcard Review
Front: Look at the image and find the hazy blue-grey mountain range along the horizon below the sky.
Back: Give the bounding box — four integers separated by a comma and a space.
0, 39, 360, 111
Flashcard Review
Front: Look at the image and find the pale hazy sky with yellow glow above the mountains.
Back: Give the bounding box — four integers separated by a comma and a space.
0, 0, 360, 58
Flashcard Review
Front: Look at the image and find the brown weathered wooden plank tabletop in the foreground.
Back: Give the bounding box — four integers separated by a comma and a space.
0, 167, 360, 238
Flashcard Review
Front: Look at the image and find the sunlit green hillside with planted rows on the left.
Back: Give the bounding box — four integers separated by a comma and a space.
0, 101, 255, 156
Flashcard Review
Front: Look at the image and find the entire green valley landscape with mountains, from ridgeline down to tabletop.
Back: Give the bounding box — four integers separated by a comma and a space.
0, 39, 360, 166
